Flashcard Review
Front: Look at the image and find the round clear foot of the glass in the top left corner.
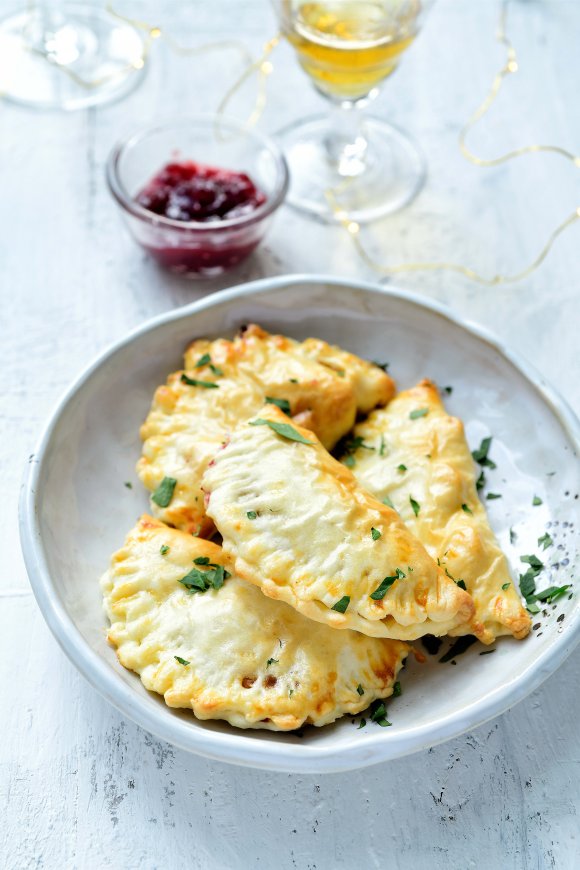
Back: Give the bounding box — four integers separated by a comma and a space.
0, 3, 145, 110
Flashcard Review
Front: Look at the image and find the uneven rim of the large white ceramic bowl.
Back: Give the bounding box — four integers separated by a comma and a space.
19, 274, 580, 773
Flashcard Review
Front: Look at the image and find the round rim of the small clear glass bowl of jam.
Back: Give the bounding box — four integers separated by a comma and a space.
105, 113, 290, 233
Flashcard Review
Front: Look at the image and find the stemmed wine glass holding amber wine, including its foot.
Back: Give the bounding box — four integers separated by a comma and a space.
273, 0, 431, 222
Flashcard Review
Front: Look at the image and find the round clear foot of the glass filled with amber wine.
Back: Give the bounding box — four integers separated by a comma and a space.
278, 116, 427, 223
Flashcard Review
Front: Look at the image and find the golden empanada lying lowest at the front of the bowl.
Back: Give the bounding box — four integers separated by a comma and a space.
101, 516, 409, 731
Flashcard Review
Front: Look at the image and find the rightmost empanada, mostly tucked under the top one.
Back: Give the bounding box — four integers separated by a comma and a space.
347, 380, 530, 643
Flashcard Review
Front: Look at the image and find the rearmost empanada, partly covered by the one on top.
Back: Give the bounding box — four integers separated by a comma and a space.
137, 326, 394, 536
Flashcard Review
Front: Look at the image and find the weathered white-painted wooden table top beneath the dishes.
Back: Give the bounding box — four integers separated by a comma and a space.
0, 0, 580, 870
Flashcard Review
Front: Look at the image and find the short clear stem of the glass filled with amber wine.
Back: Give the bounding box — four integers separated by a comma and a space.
325, 102, 368, 178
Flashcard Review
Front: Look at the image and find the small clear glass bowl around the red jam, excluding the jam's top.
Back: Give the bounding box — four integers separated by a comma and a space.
107, 115, 288, 278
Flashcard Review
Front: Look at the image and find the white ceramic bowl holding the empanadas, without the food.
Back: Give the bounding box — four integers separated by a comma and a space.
21, 276, 580, 772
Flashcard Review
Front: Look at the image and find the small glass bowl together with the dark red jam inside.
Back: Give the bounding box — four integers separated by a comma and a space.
107, 115, 289, 277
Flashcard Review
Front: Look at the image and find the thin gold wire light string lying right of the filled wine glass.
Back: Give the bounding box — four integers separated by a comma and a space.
326, 0, 580, 287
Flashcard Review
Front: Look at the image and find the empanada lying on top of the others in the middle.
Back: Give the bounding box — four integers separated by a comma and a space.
202, 405, 473, 640
